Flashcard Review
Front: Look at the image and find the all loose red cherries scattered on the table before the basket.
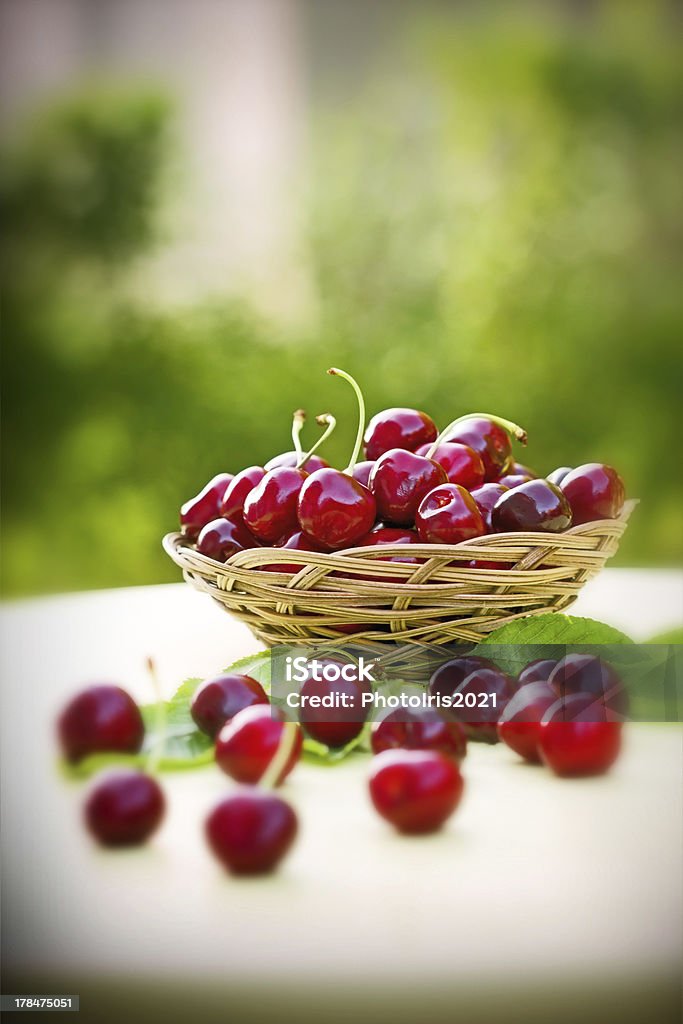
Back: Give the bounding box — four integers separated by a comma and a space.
58, 654, 627, 874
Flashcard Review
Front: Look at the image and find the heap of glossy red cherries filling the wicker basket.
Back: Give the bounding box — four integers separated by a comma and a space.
180, 369, 625, 572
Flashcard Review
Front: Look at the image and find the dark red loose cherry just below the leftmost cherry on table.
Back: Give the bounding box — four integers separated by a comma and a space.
85, 770, 166, 847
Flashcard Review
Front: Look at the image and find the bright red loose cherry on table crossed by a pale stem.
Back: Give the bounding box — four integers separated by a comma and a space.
216, 705, 303, 785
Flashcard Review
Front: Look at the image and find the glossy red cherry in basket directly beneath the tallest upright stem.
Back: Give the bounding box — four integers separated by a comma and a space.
298, 469, 377, 550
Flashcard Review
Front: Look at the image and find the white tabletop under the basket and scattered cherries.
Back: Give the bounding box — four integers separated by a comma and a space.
1, 569, 683, 1016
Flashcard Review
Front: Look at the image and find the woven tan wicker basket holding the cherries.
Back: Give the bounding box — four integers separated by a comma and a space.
164, 501, 636, 646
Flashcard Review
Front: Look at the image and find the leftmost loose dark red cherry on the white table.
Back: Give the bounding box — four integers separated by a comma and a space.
57, 683, 144, 762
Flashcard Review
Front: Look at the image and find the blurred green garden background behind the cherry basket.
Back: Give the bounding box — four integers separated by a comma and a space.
2, 0, 683, 595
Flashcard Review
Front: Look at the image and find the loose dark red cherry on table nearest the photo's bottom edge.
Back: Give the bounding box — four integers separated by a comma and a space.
206, 786, 298, 874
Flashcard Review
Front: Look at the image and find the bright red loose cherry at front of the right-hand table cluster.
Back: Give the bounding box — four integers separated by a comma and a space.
539, 694, 622, 776
